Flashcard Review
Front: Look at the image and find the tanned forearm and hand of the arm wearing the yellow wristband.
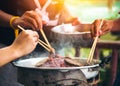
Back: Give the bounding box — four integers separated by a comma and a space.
0, 10, 42, 30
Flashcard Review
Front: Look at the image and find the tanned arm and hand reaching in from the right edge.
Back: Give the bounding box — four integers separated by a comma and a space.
86, 18, 120, 37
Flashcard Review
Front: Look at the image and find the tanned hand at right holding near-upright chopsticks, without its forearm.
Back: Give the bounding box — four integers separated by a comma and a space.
90, 19, 113, 37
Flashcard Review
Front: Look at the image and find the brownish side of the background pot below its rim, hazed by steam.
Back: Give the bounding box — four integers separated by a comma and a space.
51, 27, 93, 49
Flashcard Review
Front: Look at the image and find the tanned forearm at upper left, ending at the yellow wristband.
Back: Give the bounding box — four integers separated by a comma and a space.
0, 10, 13, 27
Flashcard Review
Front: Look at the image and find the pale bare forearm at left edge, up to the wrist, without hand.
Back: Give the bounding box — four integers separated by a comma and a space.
0, 46, 19, 67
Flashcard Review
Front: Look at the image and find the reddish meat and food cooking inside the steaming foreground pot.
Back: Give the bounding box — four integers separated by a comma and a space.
35, 55, 99, 67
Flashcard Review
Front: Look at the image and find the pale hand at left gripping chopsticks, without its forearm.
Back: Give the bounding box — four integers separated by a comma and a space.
12, 30, 39, 57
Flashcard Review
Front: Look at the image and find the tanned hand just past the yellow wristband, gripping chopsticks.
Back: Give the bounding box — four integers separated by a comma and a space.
12, 11, 43, 30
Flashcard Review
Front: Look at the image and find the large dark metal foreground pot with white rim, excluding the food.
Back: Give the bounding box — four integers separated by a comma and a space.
13, 57, 102, 86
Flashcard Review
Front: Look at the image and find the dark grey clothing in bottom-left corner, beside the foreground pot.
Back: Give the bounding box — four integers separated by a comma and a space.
0, 63, 20, 86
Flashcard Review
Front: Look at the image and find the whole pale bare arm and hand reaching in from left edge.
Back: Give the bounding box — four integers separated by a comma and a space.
0, 30, 39, 67
